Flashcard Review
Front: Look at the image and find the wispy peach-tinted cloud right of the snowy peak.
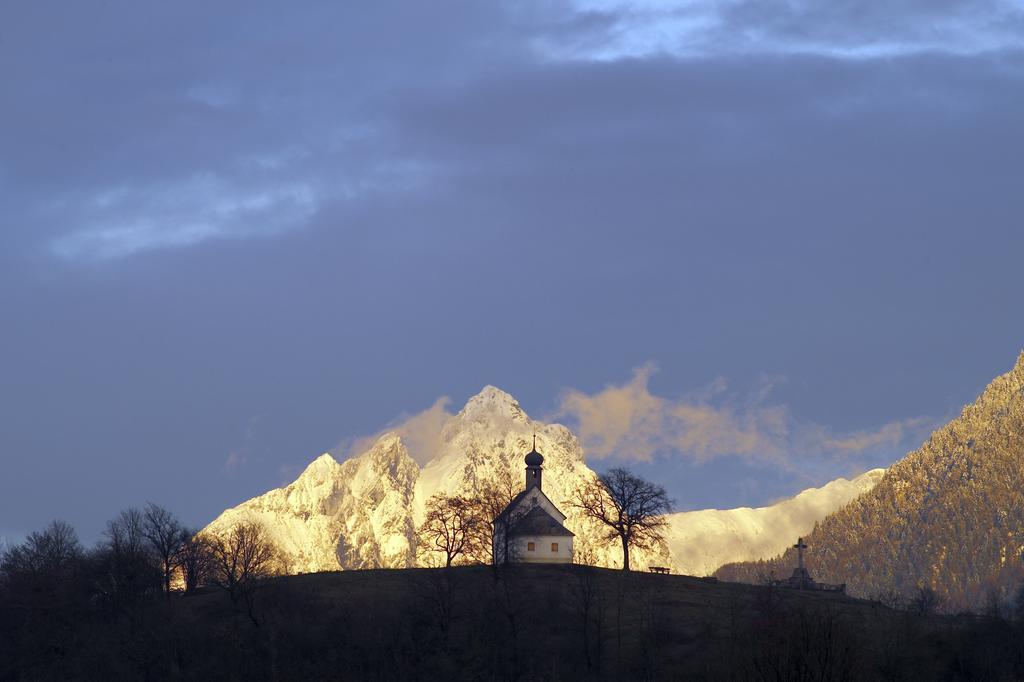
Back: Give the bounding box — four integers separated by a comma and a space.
556, 364, 934, 465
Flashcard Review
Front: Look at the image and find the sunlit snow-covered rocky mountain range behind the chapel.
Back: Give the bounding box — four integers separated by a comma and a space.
206, 386, 882, 576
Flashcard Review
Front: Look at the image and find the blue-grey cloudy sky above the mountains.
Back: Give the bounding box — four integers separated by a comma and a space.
0, 0, 1024, 542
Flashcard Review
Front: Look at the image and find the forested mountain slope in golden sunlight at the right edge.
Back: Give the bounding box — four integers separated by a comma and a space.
718, 353, 1024, 607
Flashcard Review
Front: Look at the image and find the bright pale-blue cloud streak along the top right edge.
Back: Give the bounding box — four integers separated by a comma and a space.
561, 0, 1024, 60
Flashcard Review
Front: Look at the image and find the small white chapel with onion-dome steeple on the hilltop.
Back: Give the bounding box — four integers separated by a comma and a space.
492, 436, 573, 564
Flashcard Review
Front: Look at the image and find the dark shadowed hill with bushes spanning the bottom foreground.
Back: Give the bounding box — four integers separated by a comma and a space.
6, 520, 1024, 681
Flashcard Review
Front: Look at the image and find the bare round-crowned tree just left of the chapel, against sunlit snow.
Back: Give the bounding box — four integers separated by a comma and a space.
417, 493, 485, 567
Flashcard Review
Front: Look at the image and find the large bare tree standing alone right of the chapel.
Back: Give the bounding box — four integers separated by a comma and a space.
572, 468, 672, 570
